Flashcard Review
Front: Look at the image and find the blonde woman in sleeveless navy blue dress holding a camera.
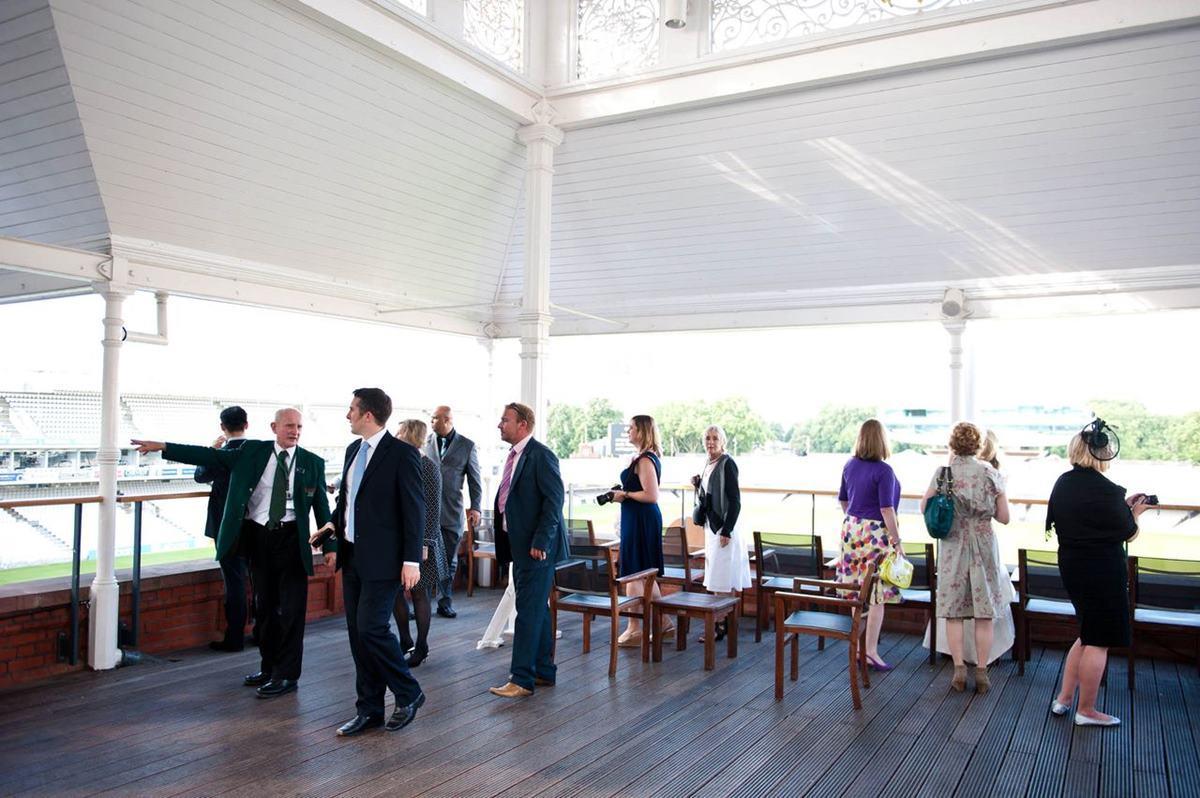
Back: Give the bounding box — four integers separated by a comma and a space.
612, 415, 674, 648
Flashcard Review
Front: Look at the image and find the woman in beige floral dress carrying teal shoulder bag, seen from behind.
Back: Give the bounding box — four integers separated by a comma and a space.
920, 422, 1013, 692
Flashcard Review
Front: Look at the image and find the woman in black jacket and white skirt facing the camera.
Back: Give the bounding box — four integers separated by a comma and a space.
691, 425, 752, 640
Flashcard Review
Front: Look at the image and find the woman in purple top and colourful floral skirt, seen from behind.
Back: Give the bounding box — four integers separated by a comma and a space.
838, 419, 900, 671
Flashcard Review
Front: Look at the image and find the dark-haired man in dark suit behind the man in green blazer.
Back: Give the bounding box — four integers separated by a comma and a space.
192, 404, 250, 652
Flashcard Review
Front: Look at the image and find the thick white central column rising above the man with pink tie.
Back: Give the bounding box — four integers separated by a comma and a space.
517, 102, 563, 425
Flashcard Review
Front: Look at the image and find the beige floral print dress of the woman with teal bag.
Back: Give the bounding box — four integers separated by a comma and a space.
930, 456, 1013, 618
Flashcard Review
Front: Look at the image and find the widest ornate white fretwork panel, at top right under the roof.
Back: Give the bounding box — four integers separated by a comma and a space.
709, 0, 983, 53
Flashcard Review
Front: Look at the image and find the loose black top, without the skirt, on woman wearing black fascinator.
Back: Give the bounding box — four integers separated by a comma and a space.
1046, 466, 1138, 551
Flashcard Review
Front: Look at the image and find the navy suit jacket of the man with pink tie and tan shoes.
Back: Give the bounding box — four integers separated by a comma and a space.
493, 438, 571, 568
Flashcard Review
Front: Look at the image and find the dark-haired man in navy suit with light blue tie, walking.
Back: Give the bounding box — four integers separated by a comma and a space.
324, 388, 427, 737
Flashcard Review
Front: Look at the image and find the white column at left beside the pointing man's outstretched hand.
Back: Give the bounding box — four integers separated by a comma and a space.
88, 283, 133, 671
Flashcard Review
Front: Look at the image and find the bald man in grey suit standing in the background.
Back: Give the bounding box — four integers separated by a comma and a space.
425, 404, 484, 618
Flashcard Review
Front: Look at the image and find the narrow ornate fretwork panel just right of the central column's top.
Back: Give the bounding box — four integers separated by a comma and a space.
575, 0, 660, 80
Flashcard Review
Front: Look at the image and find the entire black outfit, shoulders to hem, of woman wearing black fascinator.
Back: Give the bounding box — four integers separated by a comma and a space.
1046, 466, 1138, 648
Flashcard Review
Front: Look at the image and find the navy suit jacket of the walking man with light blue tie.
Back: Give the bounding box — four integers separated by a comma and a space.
334, 432, 427, 580
